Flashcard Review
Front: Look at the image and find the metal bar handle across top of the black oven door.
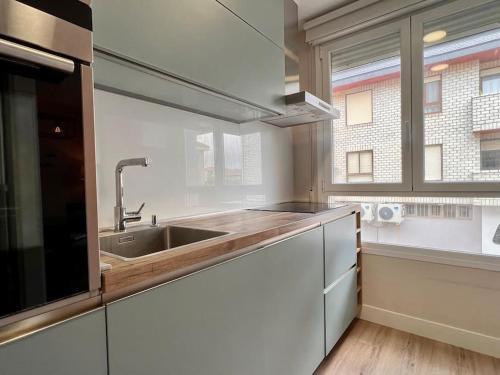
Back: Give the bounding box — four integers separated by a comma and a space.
0, 39, 75, 74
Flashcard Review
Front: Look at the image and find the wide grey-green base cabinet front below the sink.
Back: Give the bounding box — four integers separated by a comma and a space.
107, 228, 324, 375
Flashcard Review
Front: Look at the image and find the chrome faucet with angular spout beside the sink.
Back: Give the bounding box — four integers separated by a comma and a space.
115, 158, 151, 232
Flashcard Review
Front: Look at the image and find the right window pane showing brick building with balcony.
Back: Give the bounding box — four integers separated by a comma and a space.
422, 2, 500, 183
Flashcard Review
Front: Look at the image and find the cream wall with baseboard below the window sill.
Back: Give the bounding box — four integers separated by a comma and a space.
361, 254, 500, 357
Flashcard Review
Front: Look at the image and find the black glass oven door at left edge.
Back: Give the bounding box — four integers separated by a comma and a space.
0, 50, 89, 318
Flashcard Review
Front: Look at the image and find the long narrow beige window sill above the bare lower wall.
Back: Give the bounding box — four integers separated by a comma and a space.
362, 242, 500, 272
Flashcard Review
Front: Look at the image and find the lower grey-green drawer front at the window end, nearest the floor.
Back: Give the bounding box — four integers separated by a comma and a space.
325, 267, 358, 354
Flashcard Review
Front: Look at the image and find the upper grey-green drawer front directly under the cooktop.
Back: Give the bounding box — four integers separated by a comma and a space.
324, 214, 356, 288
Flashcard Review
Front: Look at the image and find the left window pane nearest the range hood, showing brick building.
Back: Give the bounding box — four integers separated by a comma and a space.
331, 33, 402, 184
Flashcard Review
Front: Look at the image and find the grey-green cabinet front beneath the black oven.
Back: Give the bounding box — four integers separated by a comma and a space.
0, 308, 107, 375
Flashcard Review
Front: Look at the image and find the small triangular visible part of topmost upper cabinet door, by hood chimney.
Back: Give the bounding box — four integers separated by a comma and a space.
217, 0, 285, 47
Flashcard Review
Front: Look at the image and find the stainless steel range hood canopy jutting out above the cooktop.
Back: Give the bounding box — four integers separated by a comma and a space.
261, 91, 340, 128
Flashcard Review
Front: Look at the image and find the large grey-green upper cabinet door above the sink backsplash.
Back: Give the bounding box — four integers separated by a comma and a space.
92, 0, 285, 112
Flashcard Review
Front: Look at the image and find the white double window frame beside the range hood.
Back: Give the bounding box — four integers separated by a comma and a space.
316, 0, 500, 198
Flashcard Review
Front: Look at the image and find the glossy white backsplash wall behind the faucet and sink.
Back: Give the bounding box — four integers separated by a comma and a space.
95, 90, 293, 227
